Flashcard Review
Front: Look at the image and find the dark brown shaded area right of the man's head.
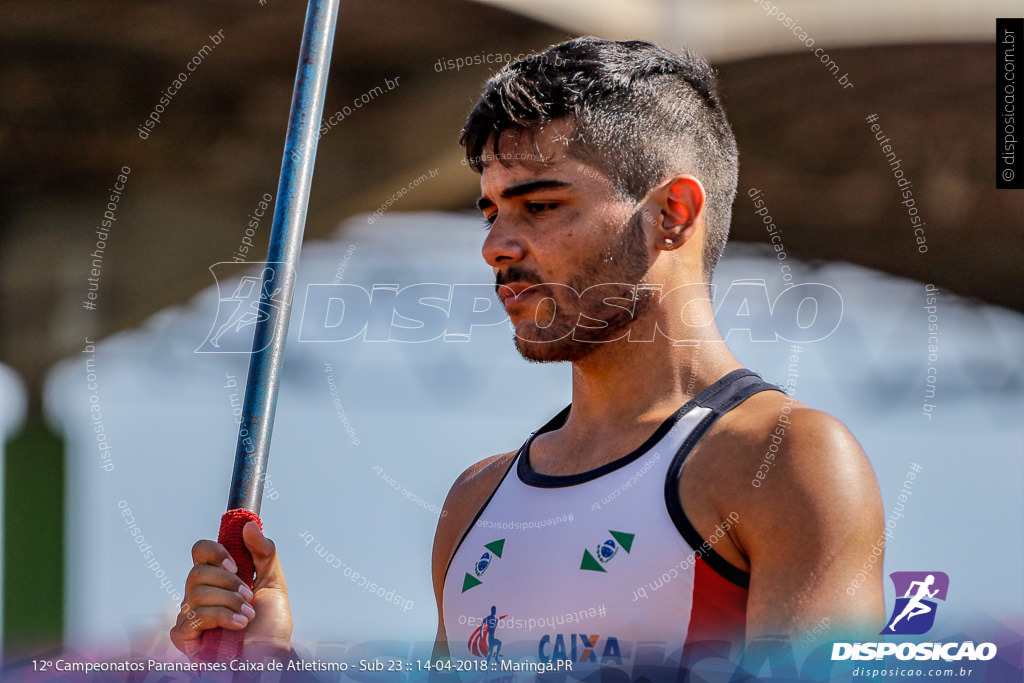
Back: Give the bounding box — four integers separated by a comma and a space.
720, 45, 1024, 310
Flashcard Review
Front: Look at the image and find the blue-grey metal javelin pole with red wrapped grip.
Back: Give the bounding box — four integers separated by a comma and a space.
200, 0, 340, 661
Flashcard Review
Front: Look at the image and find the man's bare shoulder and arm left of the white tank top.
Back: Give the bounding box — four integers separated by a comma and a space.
431, 451, 516, 659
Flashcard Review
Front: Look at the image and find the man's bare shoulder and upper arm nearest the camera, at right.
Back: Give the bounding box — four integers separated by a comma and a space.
698, 391, 885, 635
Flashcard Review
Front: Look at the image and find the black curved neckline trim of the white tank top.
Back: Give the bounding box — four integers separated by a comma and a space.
516, 370, 761, 488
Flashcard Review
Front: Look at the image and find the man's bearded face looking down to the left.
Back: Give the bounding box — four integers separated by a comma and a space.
479, 122, 650, 362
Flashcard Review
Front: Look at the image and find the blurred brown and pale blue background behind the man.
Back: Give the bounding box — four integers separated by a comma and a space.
0, 0, 1024, 661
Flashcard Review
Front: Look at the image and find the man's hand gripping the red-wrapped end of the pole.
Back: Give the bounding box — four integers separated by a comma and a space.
171, 522, 292, 658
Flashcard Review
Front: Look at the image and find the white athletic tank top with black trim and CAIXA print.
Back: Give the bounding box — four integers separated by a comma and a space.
442, 370, 777, 680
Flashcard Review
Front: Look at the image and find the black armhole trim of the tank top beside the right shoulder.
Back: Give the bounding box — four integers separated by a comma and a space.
665, 370, 784, 589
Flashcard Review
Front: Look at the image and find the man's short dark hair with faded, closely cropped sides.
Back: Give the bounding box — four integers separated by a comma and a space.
459, 36, 738, 282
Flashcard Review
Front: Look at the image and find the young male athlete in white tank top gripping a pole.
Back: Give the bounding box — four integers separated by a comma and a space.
171, 38, 885, 671
